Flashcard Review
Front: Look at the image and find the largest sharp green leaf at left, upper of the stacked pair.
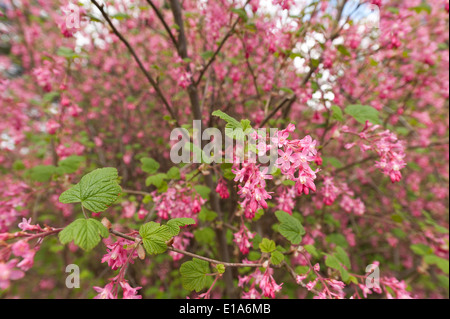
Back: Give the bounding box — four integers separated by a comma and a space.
59, 167, 122, 213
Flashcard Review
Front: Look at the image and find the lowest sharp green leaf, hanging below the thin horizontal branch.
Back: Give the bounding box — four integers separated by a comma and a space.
180, 258, 211, 292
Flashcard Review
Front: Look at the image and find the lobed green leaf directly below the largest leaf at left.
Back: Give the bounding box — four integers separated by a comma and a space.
58, 218, 109, 251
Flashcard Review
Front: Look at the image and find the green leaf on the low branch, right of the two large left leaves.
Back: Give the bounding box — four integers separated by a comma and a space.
139, 222, 173, 255
